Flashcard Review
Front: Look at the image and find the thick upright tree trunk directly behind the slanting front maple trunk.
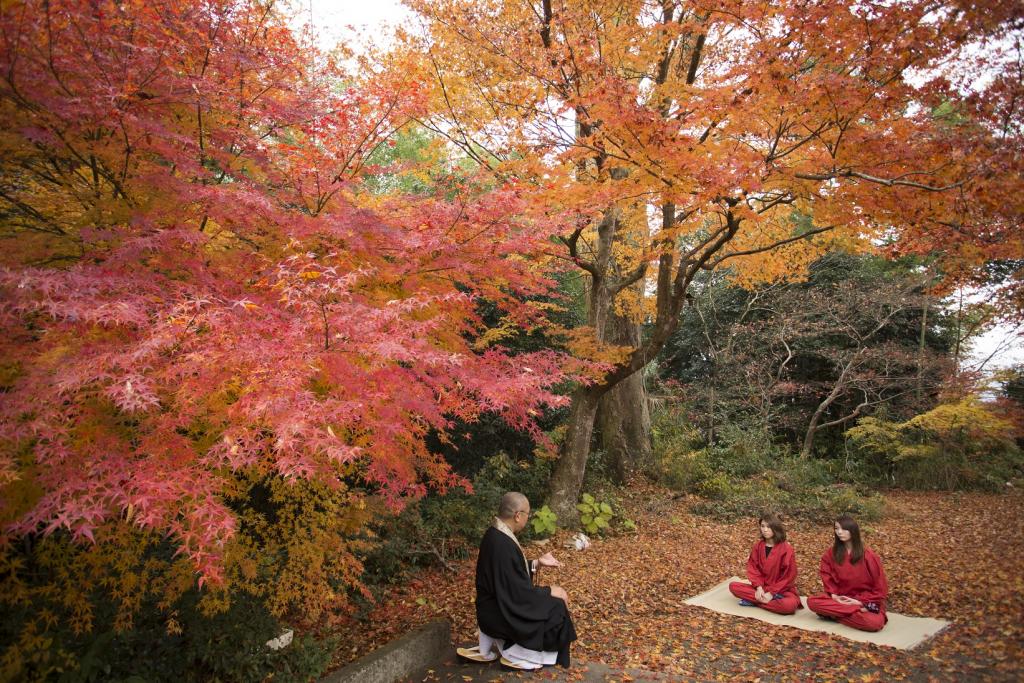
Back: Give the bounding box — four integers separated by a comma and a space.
597, 313, 651, 483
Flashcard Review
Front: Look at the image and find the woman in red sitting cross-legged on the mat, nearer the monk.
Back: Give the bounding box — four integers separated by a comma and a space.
729, 515, 803, 614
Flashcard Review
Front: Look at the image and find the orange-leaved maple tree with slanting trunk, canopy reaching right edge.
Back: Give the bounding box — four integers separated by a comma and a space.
407, 0, 1024, 516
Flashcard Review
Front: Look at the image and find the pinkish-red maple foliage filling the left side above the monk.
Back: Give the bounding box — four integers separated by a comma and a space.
0, 0, 574, 586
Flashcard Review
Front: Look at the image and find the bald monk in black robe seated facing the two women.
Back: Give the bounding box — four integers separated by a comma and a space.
459, 493, 577, 670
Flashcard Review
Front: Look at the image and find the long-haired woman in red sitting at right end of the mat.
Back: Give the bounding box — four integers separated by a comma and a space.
807, 516, 889, 631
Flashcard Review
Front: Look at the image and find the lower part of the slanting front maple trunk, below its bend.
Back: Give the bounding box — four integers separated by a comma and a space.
548, 387, 603, 526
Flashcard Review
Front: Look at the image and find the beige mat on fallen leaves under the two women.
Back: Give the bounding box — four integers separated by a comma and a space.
683, 577, 950, 650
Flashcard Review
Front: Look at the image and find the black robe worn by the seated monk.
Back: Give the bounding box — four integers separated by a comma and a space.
476, 526, 577, 667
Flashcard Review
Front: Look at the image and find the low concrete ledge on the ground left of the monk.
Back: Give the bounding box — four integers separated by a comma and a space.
321, 620, 452, 683
